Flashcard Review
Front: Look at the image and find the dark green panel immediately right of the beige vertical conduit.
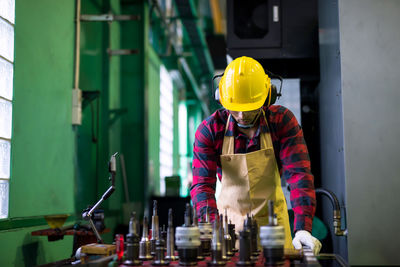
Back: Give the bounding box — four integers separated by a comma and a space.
75, 1, 108, 216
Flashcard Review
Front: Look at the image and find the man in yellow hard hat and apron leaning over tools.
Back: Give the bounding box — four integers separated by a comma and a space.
190, 57, 321, 254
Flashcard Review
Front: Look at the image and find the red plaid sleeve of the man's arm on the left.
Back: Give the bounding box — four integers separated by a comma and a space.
190, 121, 217, 221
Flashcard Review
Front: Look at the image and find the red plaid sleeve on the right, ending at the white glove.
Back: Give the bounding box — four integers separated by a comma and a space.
277, 107, 316, 232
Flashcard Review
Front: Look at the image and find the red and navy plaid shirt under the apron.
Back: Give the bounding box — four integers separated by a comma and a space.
190, 105, 316, 232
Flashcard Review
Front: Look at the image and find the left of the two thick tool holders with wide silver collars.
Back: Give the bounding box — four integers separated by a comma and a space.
175, 204, 200, 266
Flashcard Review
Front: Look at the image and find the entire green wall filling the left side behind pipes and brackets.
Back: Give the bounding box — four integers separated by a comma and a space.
0, 0, 211, 266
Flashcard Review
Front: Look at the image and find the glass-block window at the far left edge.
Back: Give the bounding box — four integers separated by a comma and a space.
0, 0, 15, 218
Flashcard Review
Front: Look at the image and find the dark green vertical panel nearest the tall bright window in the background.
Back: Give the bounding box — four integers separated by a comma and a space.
120, 2, 148, 213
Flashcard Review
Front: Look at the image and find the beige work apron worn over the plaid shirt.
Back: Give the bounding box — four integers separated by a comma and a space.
217, 111, 293, 248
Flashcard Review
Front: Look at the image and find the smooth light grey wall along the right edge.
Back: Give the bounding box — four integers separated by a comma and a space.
339, 0, 400, 265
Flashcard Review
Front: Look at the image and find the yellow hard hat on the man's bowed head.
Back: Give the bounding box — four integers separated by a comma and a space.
219, 57, 271, 111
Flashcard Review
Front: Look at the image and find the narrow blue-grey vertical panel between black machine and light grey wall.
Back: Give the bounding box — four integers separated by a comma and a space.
317, 0, 347, 259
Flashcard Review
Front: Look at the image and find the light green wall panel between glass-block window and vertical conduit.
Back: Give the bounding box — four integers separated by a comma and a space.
10, 0, 74, 217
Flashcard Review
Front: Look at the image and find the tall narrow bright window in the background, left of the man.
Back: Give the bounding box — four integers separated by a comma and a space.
160, 66, 174, 195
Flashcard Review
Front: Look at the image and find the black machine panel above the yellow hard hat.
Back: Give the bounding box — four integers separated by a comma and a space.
227, 0, 318, 59
